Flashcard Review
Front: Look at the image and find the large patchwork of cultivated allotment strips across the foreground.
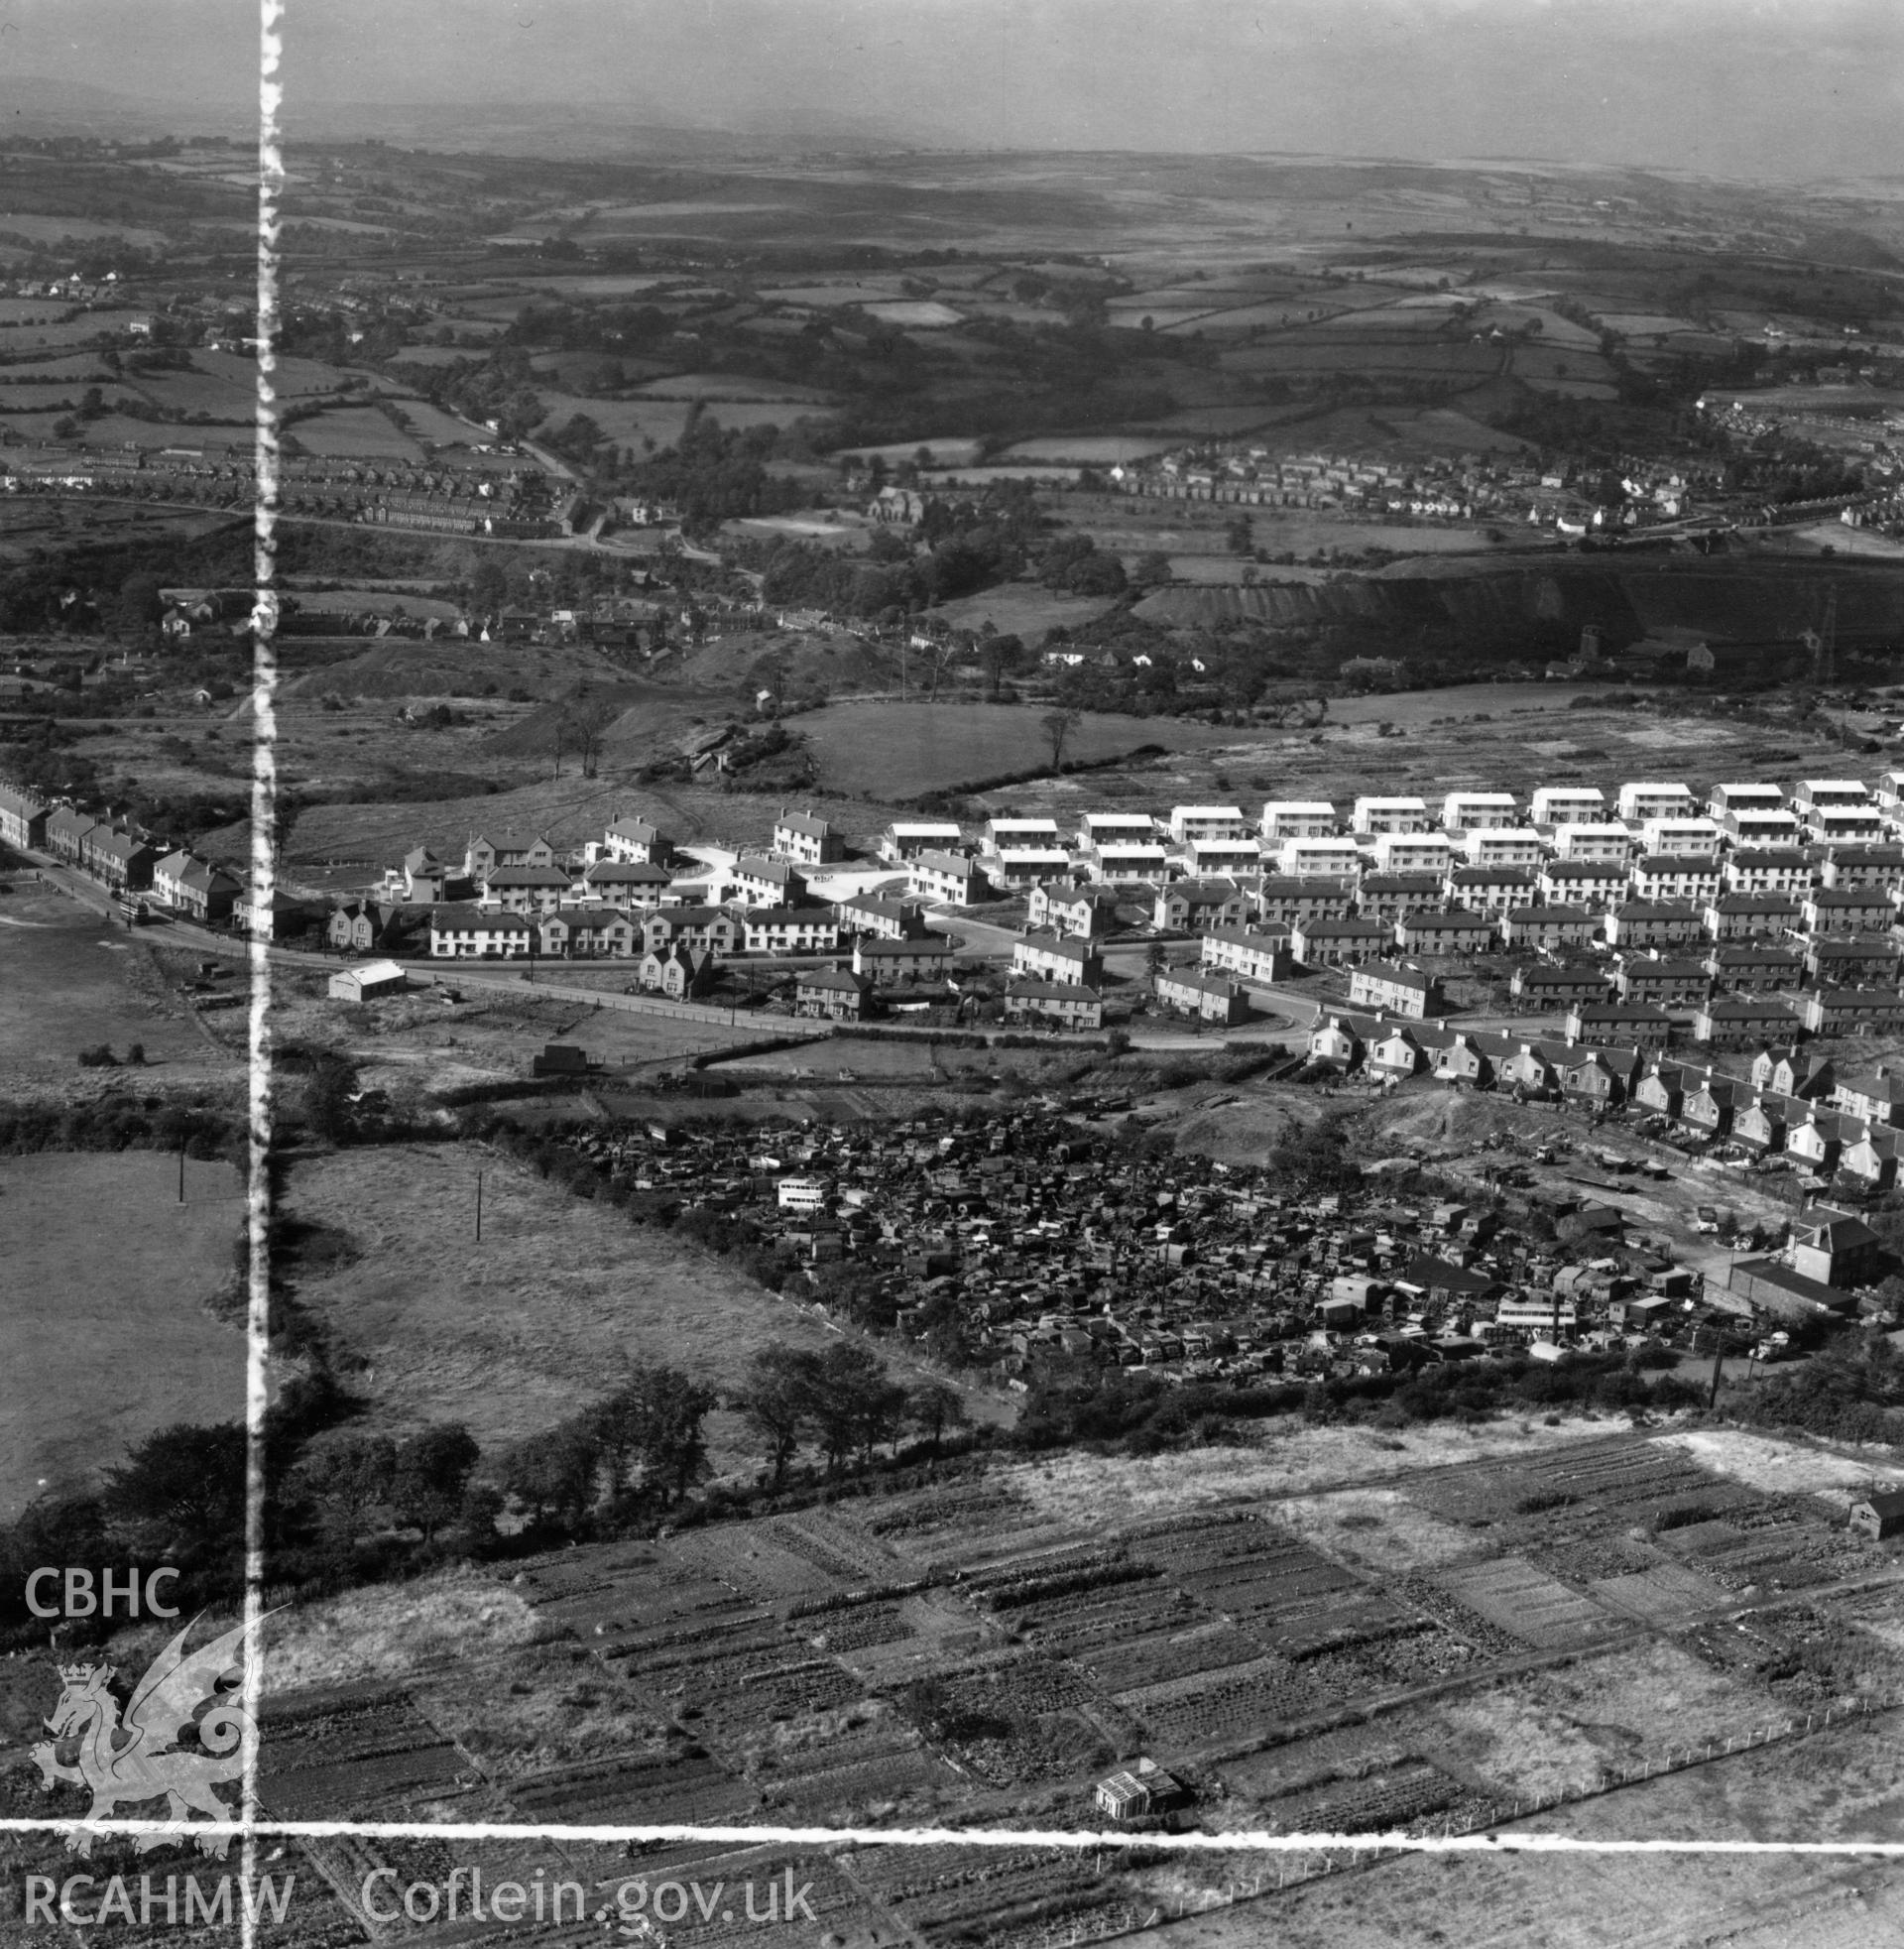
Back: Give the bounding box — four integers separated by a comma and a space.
66, 1430, 1904, 1949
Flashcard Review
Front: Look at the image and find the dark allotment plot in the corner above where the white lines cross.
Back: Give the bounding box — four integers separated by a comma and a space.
257, 1682, 476, 1820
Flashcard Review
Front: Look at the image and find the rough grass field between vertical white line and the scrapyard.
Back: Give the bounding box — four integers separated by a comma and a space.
287, 1144, 990, 1472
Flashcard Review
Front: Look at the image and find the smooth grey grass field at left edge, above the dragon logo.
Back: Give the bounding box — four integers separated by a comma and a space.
0, 1150, 246, 1521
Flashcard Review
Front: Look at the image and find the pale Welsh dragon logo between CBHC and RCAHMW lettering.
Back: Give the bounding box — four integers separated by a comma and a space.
31, 1618, 257, 1860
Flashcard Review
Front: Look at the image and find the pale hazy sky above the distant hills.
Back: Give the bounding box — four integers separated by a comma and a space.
11, 0, 1904, 180
